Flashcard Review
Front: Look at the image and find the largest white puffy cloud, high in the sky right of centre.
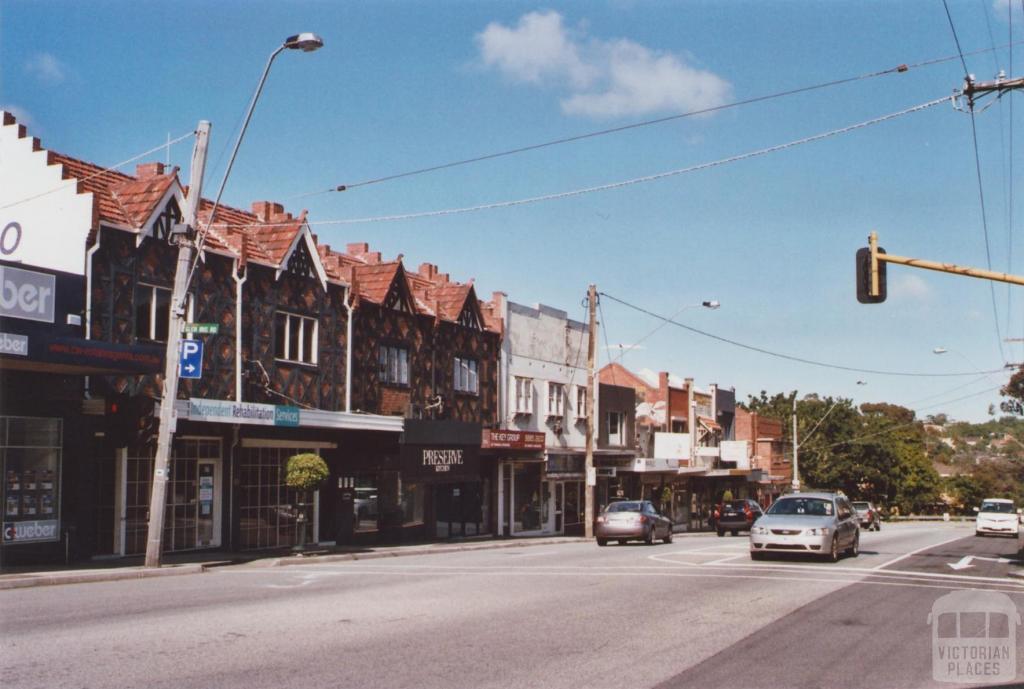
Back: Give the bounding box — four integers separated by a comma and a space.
476, 11, 732, 118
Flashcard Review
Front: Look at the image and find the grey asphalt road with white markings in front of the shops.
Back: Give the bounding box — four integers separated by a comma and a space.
0, 523, 1024, 689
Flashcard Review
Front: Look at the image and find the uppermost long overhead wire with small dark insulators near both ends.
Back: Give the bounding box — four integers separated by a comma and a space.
286, 43, 1014, 201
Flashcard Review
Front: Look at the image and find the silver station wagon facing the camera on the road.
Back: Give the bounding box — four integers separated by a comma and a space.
751, 492, 860, 562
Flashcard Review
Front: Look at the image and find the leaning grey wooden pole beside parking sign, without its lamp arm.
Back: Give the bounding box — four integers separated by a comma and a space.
145, 120, 213, 567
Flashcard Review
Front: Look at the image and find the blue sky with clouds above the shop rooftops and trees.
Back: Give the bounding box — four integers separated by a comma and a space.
0, 0, 1024, 421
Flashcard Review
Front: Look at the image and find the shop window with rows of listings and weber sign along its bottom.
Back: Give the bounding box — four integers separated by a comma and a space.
0, 417, 62, 546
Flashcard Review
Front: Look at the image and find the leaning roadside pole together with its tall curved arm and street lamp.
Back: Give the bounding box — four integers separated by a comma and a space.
145, 33, 324, 567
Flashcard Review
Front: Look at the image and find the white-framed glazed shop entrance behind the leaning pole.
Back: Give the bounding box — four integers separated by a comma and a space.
115, 437, 222, 556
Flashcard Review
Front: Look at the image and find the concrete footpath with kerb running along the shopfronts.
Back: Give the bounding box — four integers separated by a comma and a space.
0, 534, 589, 591
